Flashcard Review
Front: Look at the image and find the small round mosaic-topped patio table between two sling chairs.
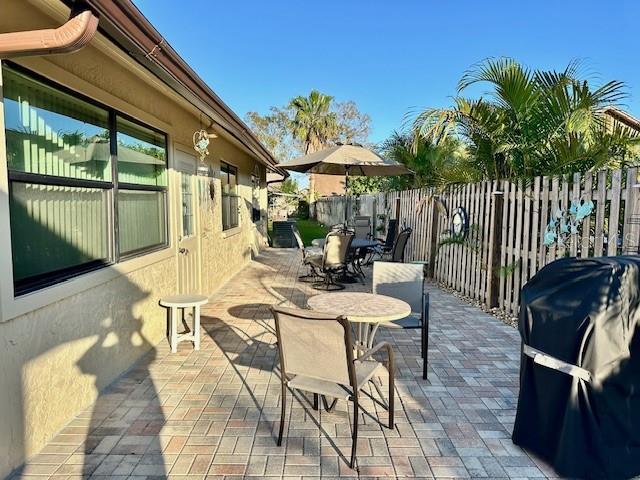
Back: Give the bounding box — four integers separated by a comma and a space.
307, 292, 411, 352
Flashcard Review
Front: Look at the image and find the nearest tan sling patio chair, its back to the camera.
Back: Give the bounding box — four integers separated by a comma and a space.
271, 307, 395, 468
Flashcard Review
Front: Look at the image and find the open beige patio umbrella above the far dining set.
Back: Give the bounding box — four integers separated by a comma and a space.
278, 143, 413, 223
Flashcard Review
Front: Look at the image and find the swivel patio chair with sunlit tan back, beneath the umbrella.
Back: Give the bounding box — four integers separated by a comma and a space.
309, 231, 354, 291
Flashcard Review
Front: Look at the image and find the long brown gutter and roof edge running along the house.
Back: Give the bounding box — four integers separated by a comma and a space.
61, 0, 288, 177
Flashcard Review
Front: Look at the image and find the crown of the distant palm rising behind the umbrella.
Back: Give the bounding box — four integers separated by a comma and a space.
289, 90, 337, 155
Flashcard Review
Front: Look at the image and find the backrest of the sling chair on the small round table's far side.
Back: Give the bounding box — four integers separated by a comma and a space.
373, 262, 424, 313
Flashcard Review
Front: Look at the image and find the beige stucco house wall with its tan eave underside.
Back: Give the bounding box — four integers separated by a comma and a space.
0, 0, 267, 478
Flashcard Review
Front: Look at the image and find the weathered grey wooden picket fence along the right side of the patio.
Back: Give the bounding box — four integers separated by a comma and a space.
313, 168, 640, 314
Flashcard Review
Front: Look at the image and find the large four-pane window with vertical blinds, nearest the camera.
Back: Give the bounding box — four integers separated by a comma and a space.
2, 65, 167, 295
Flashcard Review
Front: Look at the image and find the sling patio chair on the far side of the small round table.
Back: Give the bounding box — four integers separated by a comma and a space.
373, 262, 429, 380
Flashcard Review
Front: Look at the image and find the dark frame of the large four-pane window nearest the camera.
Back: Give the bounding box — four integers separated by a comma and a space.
0, 60, 170, 299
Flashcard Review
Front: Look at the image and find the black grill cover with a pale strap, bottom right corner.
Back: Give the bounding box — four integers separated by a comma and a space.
512, 256, 640, 478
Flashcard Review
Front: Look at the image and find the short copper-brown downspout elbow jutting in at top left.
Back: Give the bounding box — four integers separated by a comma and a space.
0, 10, 98, 59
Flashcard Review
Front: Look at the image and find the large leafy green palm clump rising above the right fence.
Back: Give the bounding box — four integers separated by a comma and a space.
412, 58, 638, 179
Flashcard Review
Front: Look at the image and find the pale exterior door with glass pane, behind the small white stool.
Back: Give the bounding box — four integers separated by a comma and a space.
175, 150, 201, 293
